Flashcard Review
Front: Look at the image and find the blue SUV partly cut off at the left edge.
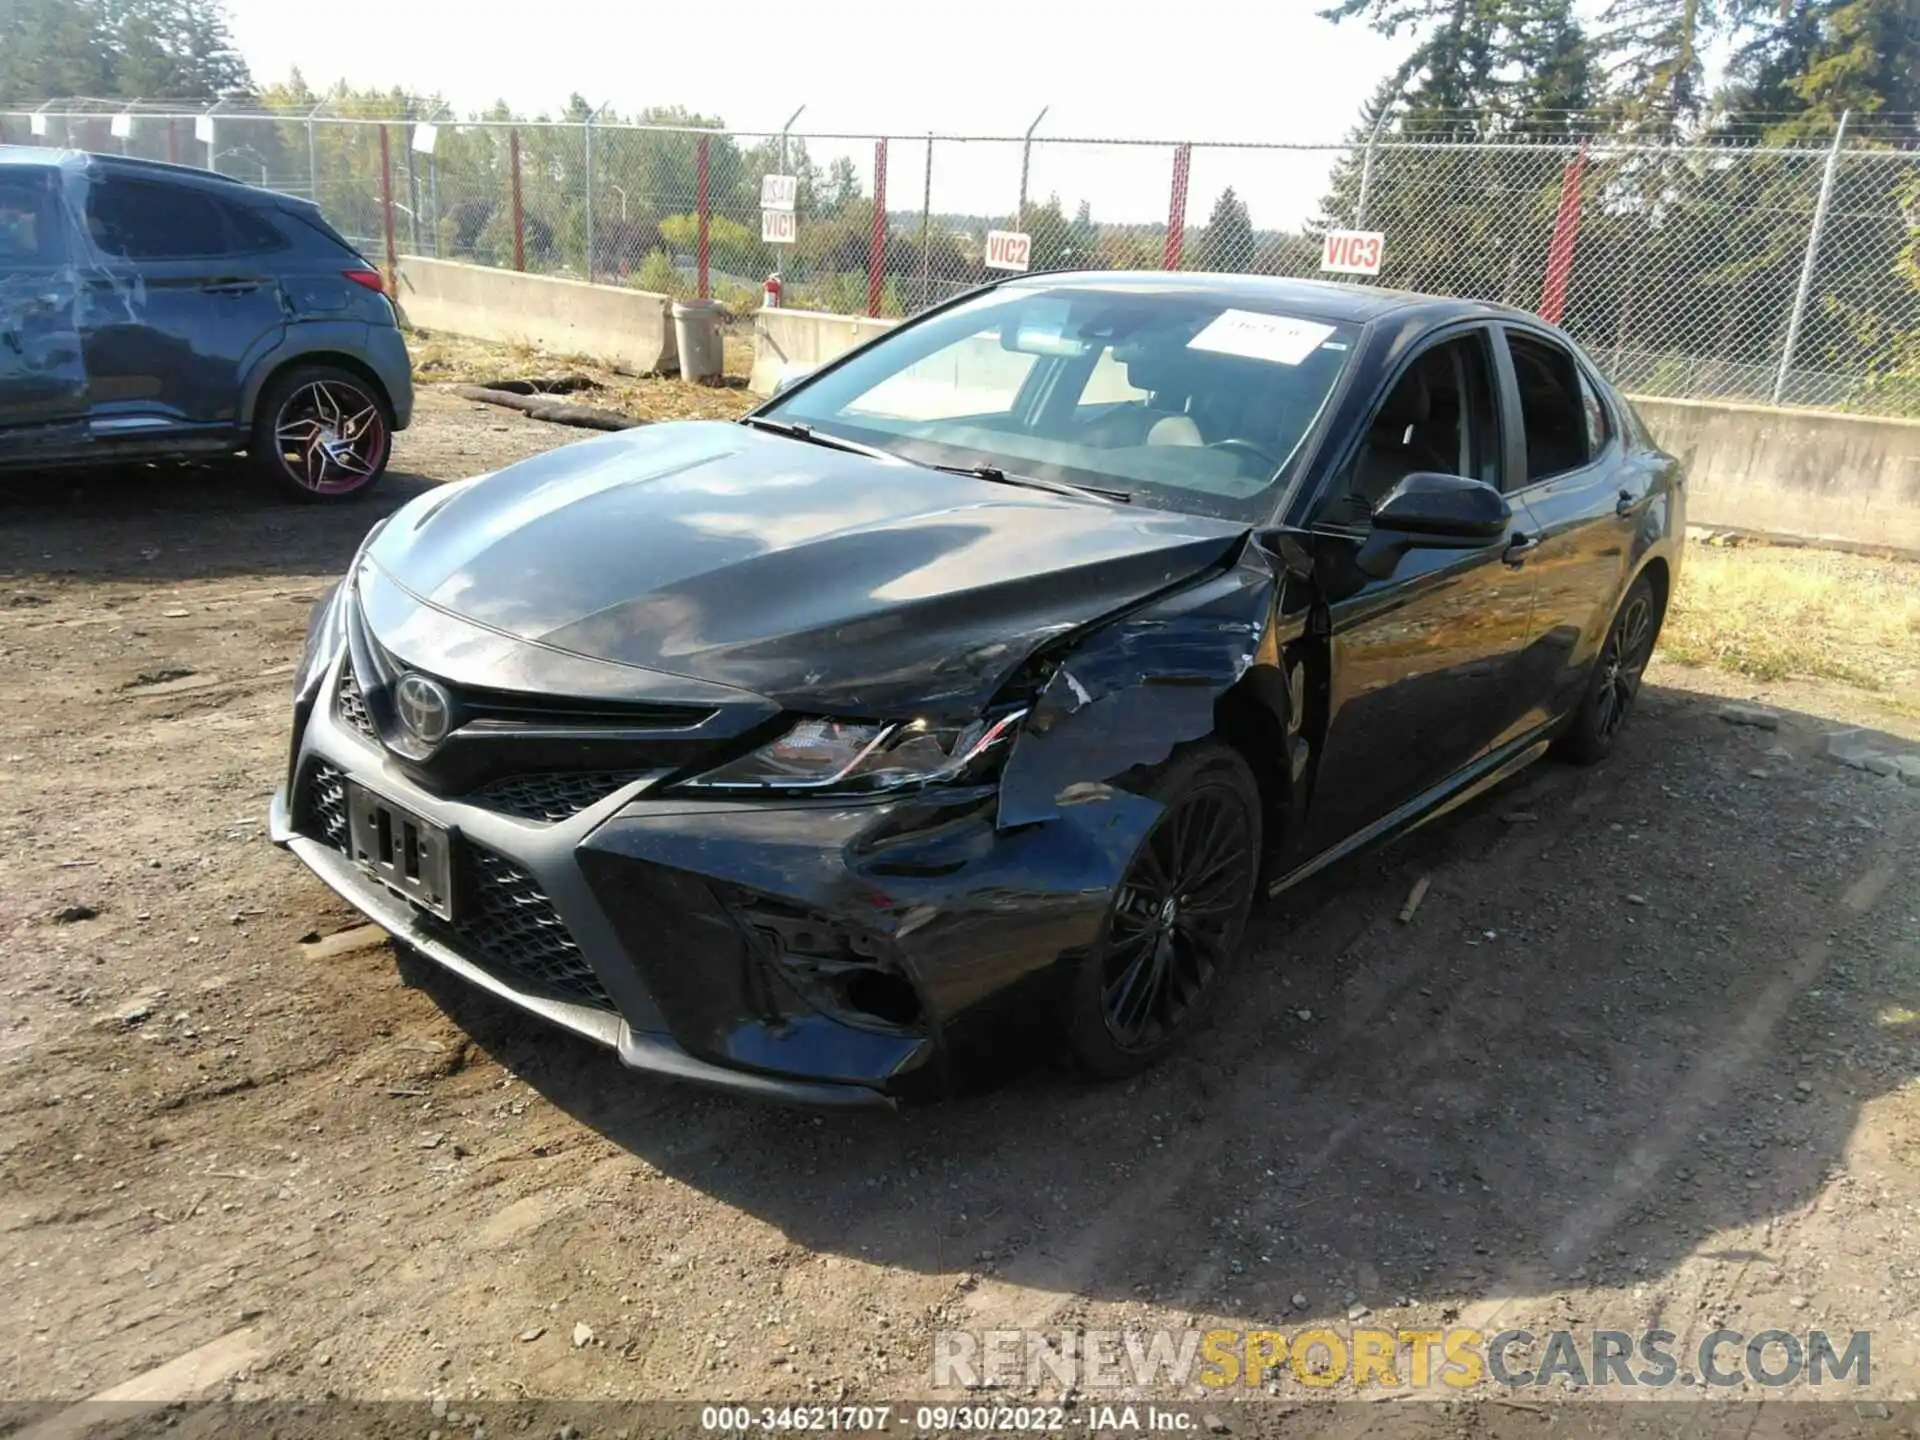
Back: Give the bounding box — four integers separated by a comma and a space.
0, 146, 413, 501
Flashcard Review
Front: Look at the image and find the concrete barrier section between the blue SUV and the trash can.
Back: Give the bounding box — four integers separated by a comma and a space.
399, 255, 678, 374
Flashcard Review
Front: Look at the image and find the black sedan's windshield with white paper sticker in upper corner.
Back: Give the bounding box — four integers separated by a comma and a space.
762, 286, 1357, 522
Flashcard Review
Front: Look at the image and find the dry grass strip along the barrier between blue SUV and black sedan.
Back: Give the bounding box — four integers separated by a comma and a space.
407, 322, 755, 420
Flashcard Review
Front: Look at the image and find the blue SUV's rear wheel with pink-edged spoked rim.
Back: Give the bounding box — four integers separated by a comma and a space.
248, 365, 394, 505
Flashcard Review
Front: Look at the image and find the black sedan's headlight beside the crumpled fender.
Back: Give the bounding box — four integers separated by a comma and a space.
684, 710, 1025, 795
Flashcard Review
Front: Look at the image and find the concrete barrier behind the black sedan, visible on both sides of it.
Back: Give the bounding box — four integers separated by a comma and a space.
751, 309, 1920, 549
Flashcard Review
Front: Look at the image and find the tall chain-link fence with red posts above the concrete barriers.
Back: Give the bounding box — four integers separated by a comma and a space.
0, 102, 1920, 415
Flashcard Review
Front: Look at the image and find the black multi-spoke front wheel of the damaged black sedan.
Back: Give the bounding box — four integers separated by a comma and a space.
1066, 739, 1261, 1079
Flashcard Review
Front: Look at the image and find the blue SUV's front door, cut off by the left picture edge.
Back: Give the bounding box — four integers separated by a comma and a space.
0, 165, 88, 459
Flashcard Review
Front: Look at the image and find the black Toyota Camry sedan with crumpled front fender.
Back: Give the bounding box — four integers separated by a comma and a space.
273, 275, 1684, 1104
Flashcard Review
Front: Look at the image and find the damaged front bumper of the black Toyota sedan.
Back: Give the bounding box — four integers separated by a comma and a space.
271, 664, 1160, 1106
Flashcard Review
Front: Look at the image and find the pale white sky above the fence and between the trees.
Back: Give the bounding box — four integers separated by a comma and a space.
228, 0, 1407, 227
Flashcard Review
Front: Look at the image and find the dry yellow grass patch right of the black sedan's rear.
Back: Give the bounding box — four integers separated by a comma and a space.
1661, 545, 1920, 714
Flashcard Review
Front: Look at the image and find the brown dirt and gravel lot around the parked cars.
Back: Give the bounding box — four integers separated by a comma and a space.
0, 378, 1920, 1434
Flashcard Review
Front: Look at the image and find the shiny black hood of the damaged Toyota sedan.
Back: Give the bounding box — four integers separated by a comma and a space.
367, 422, 1246, 716
